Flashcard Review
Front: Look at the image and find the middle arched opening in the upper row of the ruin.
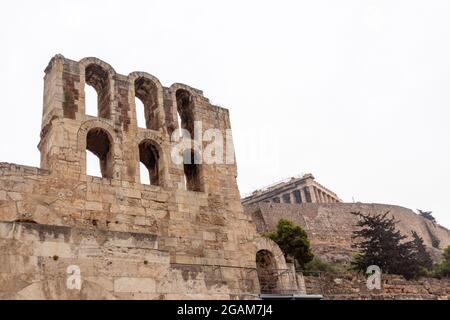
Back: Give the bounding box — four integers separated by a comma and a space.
134, 77, 159, 130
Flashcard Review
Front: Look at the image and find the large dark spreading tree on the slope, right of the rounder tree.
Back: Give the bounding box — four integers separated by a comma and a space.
351, 212, 426, 279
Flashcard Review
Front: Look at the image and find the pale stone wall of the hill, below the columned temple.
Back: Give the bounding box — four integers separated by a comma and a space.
244, 203, 450, 262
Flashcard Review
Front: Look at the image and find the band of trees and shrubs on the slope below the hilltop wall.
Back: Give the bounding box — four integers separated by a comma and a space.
265, 212, 450, 279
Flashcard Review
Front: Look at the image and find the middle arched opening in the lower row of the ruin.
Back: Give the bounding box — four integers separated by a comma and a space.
139, 140, 160, 186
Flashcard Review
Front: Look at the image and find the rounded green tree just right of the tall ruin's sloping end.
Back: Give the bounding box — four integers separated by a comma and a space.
266, 219, 314, 268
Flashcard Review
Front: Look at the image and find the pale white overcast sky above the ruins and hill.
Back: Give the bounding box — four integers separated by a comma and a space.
0, 0, 450, 227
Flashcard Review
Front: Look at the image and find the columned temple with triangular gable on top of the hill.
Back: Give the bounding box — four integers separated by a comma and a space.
242, 174, 342, 205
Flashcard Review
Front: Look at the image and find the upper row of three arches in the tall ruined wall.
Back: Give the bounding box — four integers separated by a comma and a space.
79, 58, 194, 135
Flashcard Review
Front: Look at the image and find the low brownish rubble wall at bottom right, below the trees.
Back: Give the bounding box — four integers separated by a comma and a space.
303, 273, 450, 300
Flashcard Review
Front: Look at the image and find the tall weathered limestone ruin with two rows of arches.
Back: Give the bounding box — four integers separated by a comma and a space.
0, 55, 286, 299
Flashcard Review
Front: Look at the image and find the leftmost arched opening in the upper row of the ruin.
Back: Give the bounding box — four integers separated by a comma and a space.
85, 64, 111, 119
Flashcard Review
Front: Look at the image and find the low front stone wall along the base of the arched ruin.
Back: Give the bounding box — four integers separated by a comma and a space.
0, 222, 264, 299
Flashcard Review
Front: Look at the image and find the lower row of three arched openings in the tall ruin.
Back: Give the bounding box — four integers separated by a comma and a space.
86, 128, 203, 191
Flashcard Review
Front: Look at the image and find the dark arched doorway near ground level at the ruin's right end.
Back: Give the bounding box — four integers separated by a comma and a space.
256, 250, 278, 293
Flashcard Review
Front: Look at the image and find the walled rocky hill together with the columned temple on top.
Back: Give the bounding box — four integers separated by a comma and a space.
242, 174, 450, 263
